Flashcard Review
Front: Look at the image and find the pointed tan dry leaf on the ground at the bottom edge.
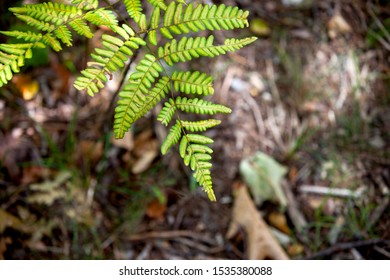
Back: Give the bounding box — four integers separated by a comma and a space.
226, 182, 289, 260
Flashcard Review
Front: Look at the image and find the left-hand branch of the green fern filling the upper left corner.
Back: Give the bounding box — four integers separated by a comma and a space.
0, 0, 117, 85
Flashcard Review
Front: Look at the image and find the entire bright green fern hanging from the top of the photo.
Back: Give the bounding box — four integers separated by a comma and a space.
0, 0, 256, 201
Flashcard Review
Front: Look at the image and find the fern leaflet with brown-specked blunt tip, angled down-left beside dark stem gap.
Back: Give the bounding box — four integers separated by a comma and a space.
74, 25, 146, 96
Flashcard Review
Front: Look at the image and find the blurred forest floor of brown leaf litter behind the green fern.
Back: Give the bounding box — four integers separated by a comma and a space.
0, 0, 390, 259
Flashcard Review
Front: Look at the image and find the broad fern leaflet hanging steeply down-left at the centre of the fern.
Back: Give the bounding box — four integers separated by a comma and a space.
114, 54, 163, 138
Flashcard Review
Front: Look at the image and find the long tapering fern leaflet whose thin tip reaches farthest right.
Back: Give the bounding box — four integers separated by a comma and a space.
158, 35, 257, 66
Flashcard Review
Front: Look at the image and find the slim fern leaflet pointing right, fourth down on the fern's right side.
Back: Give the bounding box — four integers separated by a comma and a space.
174, 96, 232, 115
